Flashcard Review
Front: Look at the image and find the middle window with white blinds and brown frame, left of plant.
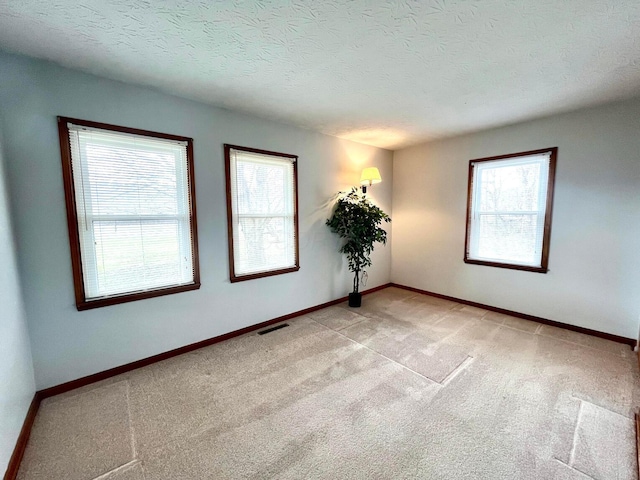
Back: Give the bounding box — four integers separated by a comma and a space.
224, 145, 300, 282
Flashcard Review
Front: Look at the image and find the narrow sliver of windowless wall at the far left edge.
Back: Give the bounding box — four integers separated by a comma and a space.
0, 128, 35, 474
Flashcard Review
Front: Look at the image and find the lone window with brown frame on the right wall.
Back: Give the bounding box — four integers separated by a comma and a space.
464, 147, 558, 273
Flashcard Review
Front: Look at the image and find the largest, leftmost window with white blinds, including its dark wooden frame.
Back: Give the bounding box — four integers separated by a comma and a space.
58, 117, 200, 310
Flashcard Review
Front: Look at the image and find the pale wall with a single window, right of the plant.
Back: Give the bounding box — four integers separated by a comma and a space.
391, 100, 640, 339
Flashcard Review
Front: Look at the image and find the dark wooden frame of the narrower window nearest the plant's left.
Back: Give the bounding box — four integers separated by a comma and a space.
224, 143, 300, 283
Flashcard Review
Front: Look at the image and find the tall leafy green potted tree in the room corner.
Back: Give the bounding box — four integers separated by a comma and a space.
327, 187, 391, 307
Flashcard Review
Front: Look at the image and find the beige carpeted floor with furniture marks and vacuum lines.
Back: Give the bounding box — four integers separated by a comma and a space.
19, 288, 640, 480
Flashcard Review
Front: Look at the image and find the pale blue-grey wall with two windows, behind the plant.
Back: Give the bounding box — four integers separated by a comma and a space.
0, 53, 392, 389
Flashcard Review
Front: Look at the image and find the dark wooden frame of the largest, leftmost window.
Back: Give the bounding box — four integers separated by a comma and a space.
57, 116, 201, 311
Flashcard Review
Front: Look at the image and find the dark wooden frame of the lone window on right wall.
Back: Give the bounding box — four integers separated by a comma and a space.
464, 147, 558, 273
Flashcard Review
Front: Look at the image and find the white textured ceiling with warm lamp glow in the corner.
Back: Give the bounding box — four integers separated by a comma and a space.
0, 0, 640, 149
